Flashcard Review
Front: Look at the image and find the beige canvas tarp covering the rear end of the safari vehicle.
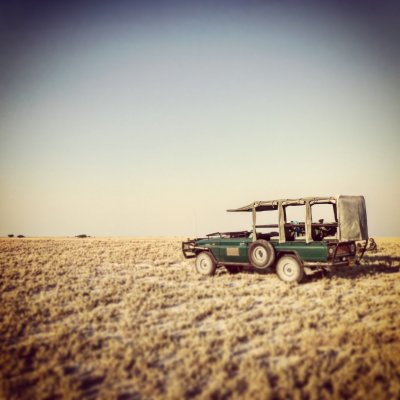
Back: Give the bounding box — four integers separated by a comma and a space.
337, 196, 368, 242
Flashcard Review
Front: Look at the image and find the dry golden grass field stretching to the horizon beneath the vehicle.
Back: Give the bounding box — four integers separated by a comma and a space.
0, 238, 400, 400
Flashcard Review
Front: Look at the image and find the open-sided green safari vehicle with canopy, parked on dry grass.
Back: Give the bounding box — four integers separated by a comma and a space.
182, 196, 368, 282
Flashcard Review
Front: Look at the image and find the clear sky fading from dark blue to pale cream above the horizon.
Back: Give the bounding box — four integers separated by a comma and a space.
0, 0, 400, 236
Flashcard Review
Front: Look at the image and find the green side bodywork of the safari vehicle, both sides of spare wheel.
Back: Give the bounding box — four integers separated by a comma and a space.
196, 237, 328, 264
